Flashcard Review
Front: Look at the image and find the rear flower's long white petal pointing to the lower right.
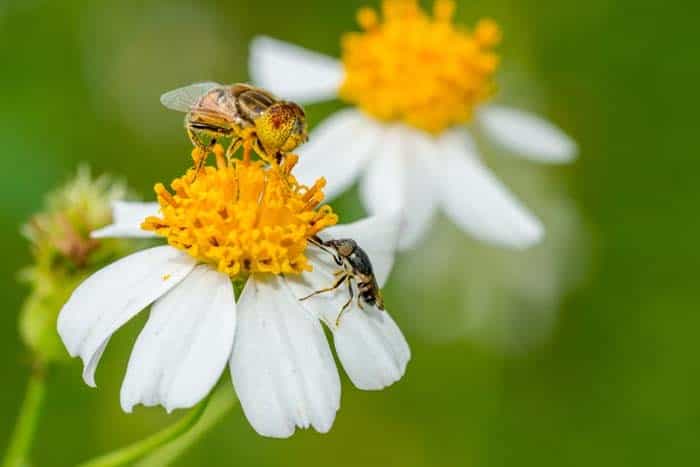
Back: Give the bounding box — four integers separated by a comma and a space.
440, 131, 544, 248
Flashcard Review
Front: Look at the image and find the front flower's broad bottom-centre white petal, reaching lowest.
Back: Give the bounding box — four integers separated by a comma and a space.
231, 276, 340, 438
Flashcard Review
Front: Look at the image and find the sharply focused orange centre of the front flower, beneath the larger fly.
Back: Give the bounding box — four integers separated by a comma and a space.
142, 148, 338, 277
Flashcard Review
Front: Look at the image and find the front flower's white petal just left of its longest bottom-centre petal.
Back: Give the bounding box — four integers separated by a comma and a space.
121, 266, 236, 412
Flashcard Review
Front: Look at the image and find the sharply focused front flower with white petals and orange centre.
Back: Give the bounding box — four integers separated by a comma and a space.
58, 154, 410, 437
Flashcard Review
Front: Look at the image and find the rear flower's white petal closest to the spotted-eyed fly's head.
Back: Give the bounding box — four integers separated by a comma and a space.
294, 109, 381, 199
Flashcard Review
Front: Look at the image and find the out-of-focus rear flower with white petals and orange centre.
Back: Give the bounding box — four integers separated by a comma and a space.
250, 0, 576, 252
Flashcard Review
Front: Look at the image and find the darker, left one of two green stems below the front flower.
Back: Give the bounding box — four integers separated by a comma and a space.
78, 396, 209, 467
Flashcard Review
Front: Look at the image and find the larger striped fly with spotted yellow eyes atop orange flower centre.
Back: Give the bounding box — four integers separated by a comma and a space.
160, 82, 308, 164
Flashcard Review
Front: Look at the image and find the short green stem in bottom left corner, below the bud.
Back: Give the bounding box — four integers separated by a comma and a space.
3, 364, 46, 467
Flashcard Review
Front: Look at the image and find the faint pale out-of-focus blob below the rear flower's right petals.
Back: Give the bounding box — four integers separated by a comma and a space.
393, 163, 590, 354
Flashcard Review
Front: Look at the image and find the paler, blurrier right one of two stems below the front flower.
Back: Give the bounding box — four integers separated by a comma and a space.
135, 384, 238, 467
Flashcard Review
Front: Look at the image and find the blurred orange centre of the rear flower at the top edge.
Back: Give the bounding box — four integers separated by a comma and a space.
340, 0, 501, 133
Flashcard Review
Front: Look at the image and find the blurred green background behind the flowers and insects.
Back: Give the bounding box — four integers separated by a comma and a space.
0, 0, 700, 467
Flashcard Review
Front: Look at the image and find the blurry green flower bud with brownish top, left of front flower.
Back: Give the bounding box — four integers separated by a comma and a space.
19, 167, 141, 362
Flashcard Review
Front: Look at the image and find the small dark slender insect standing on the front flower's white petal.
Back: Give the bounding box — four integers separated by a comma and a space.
299, 236, 384, 326
